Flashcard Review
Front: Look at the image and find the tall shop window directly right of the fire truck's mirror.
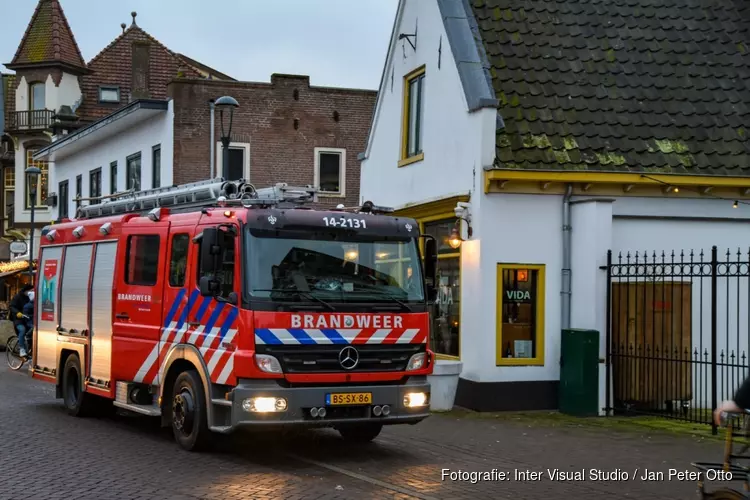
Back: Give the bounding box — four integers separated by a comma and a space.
422, 218, 461, 358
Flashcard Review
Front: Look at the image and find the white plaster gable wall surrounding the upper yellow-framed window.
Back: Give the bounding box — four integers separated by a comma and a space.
360, 0, 496, 207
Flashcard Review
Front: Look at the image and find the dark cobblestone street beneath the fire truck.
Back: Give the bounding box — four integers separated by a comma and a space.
0, 364, 736, 500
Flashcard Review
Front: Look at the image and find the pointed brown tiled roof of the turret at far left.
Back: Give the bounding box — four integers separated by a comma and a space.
6, 0, 86, 69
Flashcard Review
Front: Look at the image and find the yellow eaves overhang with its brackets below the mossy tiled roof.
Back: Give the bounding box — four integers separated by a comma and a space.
484, 168, 750, 200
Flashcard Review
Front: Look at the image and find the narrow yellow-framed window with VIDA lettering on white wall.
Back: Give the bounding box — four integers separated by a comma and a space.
495, 264, 544, 365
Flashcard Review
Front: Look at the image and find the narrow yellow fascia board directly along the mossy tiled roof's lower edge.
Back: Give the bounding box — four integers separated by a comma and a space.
484, 170, 750, 192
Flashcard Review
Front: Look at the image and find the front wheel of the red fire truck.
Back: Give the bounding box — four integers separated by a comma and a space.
171, 370, 211, 451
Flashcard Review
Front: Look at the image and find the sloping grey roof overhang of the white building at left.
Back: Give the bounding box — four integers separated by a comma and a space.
34, 99, 169, 161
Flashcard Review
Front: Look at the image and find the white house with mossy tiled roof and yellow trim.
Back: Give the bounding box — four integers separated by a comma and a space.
360, 0, 750, 412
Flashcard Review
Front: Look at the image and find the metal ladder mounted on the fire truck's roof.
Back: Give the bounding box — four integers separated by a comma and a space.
76, 177, 318, 219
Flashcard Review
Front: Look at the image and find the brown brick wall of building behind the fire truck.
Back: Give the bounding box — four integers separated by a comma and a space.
167, 74, 377, 206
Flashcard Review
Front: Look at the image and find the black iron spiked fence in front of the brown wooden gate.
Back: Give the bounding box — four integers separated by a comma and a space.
606, 246, 750, 432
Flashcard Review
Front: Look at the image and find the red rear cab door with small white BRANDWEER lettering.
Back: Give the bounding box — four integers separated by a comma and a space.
112, 219, 169, 384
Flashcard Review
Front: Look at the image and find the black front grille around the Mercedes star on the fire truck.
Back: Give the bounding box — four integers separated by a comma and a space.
257, 344, 425, 373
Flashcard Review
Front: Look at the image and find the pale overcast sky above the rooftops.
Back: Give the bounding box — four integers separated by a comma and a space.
0, 0, 398, 90
